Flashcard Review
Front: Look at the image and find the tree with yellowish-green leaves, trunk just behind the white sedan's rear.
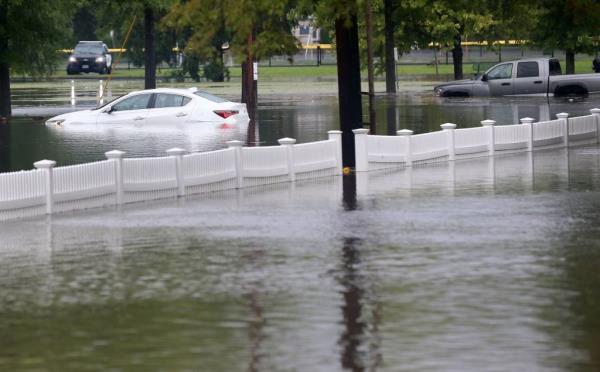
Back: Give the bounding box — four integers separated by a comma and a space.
163, 0, 298, 119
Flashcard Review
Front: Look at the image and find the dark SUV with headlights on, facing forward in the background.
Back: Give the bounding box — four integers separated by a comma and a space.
67, 41, 112, 75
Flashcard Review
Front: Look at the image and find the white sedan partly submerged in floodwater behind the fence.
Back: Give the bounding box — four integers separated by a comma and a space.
46, 88, 249, 131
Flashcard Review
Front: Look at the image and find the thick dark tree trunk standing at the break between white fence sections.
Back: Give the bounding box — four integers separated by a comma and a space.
335, 15, 363, 167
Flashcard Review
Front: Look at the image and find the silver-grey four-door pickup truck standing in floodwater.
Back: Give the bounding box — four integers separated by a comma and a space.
434, 58, 600, 97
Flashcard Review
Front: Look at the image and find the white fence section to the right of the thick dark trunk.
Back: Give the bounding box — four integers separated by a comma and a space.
353, 109, 600, 172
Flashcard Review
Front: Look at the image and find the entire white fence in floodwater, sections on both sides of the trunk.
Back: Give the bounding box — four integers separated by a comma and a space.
0, 109, 600, 220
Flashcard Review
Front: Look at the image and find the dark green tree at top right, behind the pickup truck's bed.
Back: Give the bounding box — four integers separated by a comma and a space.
533, 0, 600, 74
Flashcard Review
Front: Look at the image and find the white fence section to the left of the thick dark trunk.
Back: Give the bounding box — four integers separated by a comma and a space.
0, 131, 342, 220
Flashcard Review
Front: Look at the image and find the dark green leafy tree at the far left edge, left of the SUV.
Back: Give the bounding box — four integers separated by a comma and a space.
0, 0, 74, 117
